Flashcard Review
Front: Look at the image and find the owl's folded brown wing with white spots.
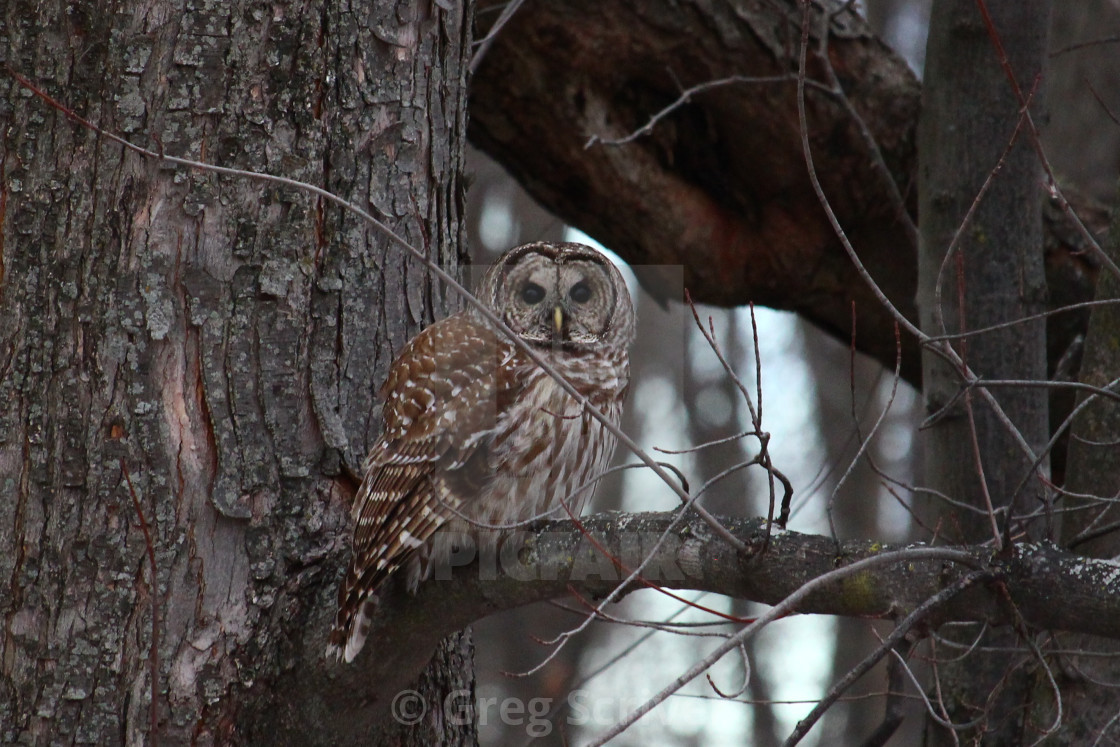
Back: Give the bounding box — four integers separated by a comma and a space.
327, 314, 517, 662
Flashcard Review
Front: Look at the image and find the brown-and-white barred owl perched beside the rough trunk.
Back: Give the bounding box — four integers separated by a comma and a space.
327, 242, 635, 662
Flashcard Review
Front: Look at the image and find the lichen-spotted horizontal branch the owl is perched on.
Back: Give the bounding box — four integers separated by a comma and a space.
302, 513, 1120, 739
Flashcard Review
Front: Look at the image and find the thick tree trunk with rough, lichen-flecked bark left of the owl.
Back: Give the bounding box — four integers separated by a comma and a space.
0, 0, 472, 744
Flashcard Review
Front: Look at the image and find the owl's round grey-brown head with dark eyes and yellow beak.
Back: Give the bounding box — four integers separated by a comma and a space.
478, 242, 634, 349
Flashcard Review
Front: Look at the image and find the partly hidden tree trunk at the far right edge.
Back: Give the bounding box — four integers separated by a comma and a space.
1034, 5, 1120, 734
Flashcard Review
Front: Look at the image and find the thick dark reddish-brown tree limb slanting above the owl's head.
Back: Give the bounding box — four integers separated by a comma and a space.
469, 0, 1103, 383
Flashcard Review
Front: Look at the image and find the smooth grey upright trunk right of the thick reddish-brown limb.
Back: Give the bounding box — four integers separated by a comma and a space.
918, 0, 1049, 744
